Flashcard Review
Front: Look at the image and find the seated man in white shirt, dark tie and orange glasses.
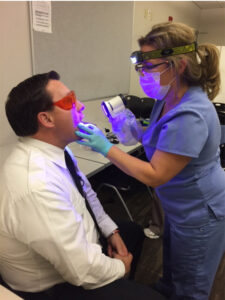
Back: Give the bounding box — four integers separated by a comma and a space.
0, 71, 163, 300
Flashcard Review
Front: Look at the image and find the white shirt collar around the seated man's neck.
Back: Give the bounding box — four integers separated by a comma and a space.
19, 137, 67, 169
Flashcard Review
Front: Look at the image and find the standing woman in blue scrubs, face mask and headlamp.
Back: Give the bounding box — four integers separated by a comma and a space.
76, 22, 225, 300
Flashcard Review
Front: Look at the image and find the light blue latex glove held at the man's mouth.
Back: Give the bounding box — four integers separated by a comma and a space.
75, 123, 113, 156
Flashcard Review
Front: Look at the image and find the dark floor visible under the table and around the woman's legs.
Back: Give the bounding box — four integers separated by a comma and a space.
89, 154, 225, 300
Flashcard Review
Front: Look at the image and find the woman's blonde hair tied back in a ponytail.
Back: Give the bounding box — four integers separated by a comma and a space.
138, 22, 220, 100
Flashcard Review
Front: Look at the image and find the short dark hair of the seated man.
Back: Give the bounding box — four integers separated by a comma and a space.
5, 71, 60, 136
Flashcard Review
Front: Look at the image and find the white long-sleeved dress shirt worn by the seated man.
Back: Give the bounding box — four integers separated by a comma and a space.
0, 138, 125, 292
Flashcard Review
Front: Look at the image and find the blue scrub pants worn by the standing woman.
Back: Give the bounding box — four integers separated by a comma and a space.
156, 211, 225, 300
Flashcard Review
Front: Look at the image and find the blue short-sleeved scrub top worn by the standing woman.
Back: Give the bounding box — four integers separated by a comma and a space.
143, 87, 225, 226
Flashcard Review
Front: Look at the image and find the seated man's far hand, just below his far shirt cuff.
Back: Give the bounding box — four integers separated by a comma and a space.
108, 233, 128, 257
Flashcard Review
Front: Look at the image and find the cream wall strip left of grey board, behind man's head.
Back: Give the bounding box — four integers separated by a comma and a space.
0, 2, 31, 147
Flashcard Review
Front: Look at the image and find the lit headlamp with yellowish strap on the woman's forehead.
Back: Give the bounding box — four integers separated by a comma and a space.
130, 42, 197, 64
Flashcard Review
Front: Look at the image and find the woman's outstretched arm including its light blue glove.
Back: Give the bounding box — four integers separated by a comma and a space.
76, 125, 191, 187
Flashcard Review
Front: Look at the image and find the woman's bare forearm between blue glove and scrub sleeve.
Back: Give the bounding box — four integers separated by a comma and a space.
107, 146, 191, 187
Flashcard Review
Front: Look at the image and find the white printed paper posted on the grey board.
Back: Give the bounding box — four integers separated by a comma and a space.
32, 1, 52, 33
